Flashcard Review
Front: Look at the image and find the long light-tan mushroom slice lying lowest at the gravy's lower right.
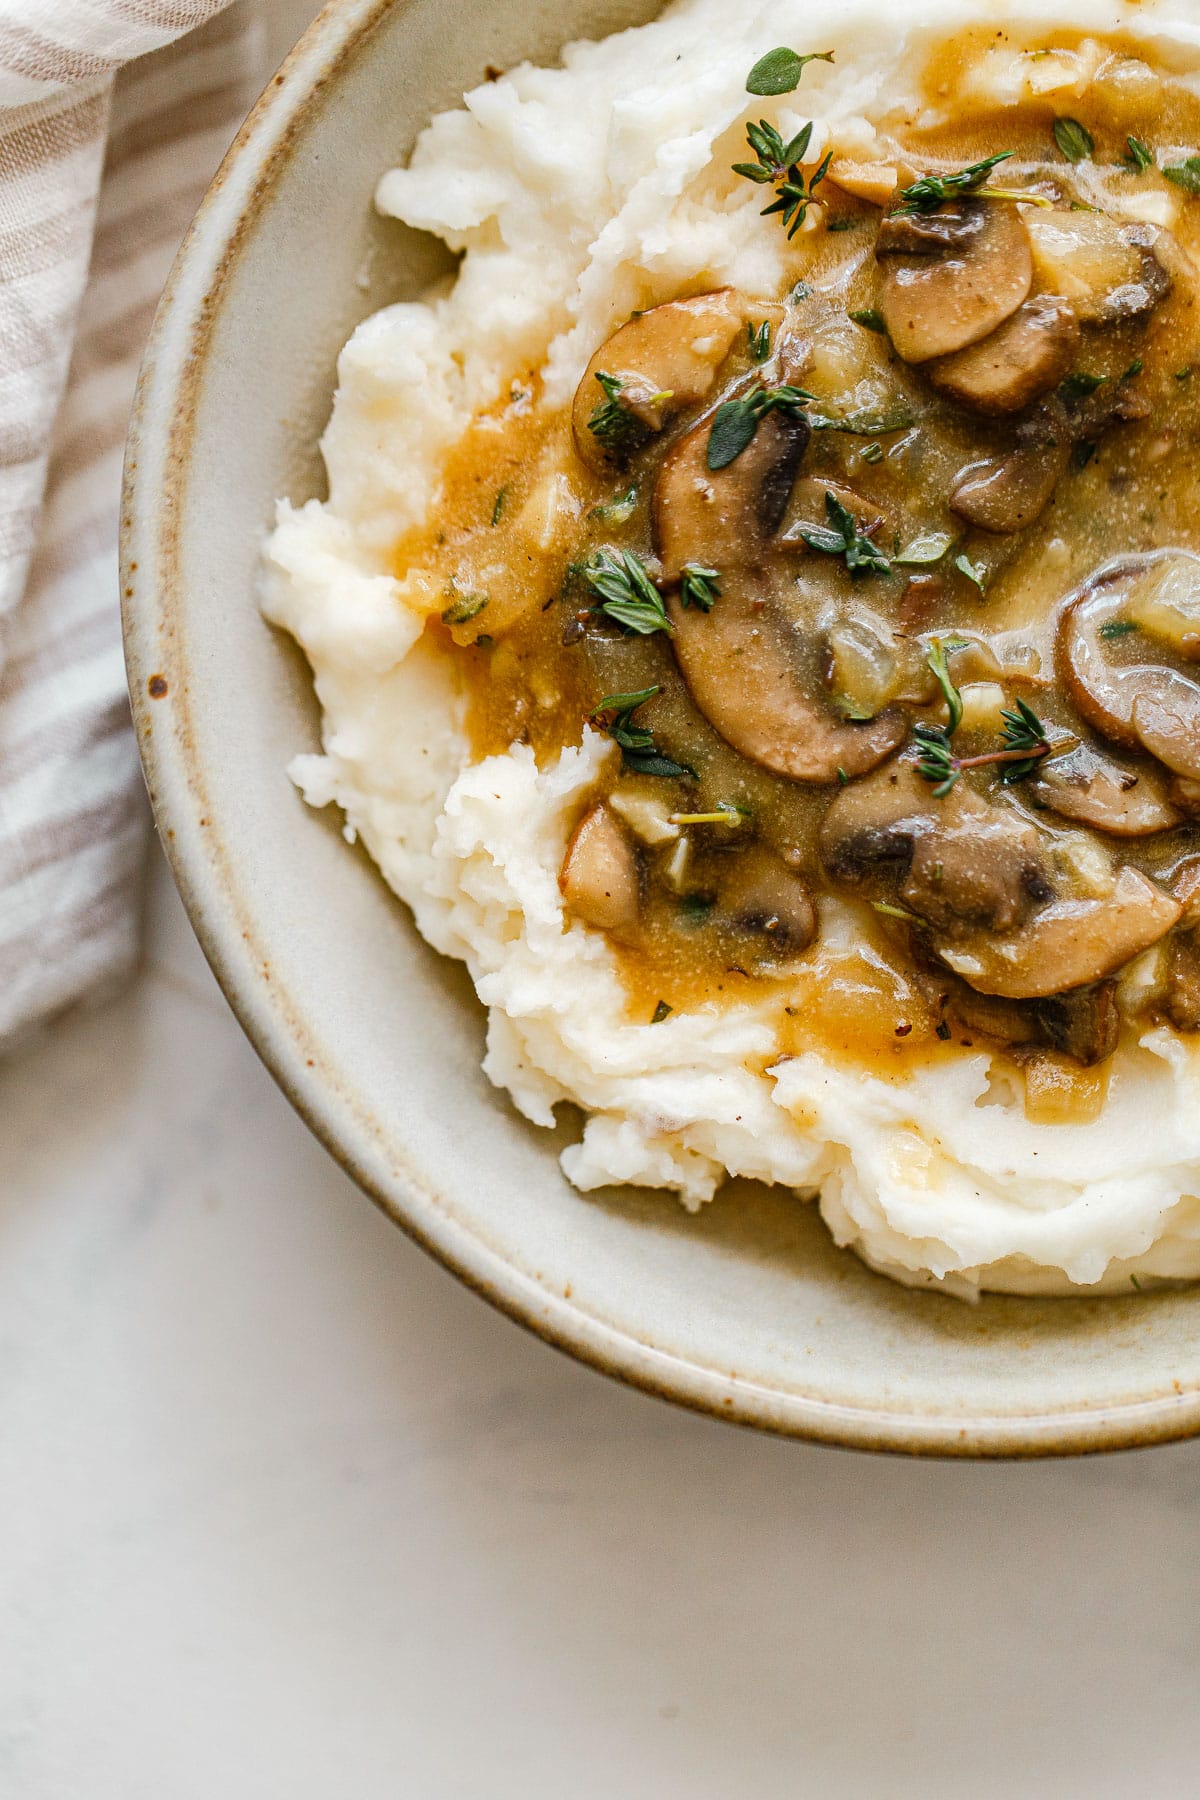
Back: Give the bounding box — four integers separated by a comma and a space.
934, 866, 1182, 999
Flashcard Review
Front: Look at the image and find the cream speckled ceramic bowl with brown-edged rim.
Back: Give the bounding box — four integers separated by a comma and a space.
122, 0, 1200, 1456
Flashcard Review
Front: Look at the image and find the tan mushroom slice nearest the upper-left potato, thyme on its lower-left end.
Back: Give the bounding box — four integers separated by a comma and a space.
570, 288, 745, 470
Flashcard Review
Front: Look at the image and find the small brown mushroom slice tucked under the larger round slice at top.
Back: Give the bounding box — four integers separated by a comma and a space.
925, 293, 1079, 414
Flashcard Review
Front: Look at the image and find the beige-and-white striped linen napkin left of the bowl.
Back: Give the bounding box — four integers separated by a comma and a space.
0, 0, 264, 1051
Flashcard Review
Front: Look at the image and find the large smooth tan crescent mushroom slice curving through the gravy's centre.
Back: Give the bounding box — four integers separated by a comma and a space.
667, 572, 907, 783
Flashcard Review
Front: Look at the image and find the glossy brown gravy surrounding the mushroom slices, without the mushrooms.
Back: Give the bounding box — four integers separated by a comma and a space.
396, 32, 1200, 1120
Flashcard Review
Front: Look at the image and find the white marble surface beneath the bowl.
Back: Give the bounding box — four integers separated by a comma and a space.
0, 0, 1200, 1800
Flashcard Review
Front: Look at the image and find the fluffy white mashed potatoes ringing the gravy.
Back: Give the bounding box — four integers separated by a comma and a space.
264, 0, 1200, 1296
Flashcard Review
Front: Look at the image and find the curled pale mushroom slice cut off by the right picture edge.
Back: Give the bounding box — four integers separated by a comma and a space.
1058, 551, 1200, 779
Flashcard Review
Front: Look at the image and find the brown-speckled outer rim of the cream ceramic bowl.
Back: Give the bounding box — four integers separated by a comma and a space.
121, 0, 1200, 1458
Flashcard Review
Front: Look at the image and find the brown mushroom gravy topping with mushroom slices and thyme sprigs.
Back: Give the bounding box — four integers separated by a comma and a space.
396, 65, 1200, 1118
